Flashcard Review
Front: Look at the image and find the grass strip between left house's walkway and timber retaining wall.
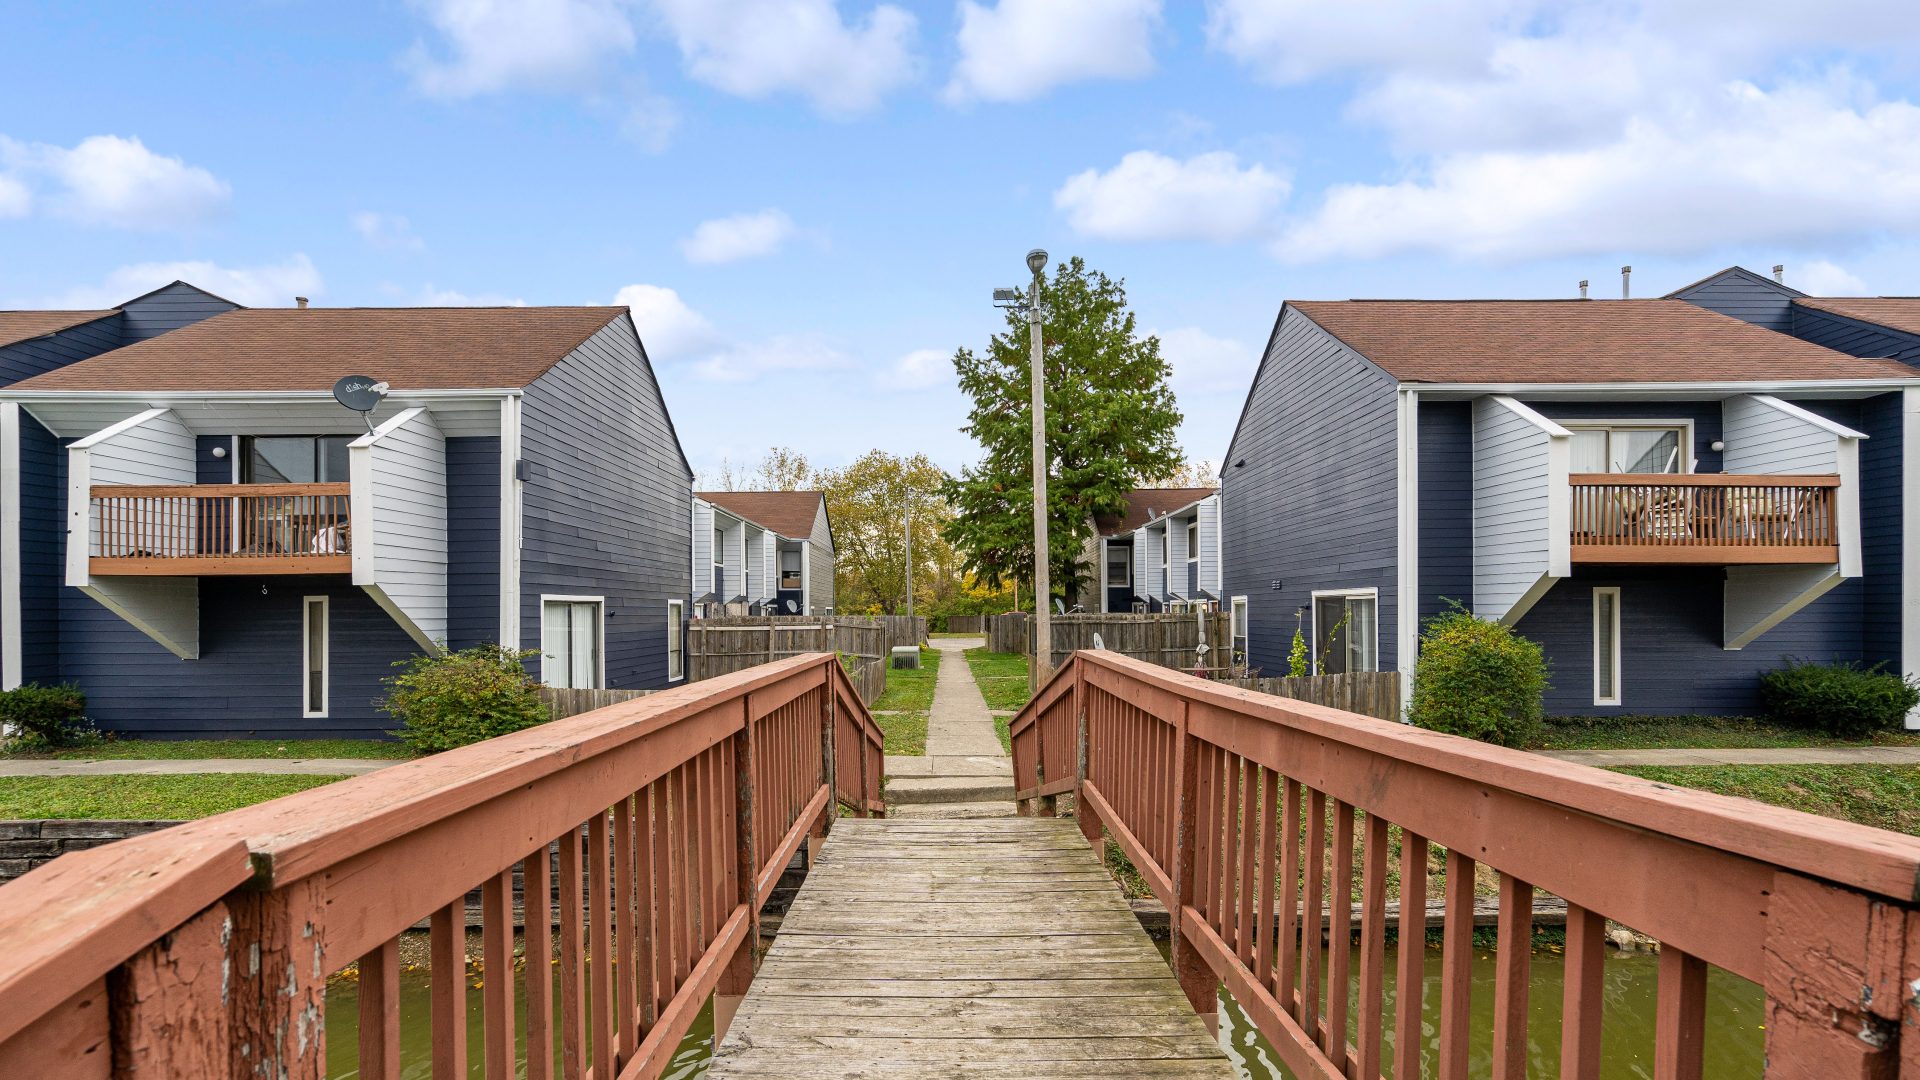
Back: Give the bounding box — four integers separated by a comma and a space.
0, 773, 342, 821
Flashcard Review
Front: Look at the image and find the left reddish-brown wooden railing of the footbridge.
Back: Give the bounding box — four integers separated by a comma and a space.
0, 655, 883, 1080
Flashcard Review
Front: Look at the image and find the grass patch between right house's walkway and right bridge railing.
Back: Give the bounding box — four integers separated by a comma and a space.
1615, 765, 1920, 836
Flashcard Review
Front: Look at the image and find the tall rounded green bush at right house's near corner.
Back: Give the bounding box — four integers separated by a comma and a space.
1409, 607, 1548, 746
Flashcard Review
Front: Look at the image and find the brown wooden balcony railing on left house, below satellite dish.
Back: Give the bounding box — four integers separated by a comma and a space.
88, 484, 353, 577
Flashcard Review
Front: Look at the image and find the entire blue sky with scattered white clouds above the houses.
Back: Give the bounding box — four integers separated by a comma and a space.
0, 0, 1920, 469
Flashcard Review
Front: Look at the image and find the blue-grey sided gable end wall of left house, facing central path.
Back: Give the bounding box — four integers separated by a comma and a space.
520, 315, 693, 688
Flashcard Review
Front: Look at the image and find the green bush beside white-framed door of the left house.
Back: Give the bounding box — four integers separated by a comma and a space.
380, 644, 549, 753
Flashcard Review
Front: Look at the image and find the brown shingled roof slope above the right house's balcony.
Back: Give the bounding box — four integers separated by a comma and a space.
1288, 300, 1914, 382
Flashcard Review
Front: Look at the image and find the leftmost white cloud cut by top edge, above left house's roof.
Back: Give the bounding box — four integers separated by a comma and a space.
403, 0, 634, 98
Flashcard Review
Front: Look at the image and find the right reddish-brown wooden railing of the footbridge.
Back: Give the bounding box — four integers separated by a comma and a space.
1012, 651, 1920, 1080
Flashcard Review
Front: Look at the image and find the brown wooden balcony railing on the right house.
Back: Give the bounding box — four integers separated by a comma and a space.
1569, 473, 1839, 565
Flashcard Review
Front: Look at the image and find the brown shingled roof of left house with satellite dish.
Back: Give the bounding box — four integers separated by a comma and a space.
12, 307, 624, 392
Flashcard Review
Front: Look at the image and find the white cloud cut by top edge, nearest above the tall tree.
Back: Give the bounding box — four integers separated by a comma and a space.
947, 0, 1160, 104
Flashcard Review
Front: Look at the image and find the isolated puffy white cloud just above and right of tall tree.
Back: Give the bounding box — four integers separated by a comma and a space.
1054, 150, 1288, 242
